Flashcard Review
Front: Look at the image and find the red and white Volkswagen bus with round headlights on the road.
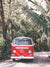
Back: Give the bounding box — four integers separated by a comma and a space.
11, 37, 34, 61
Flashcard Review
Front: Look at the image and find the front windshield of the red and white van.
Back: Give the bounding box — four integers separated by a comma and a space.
14, 39, 32, 45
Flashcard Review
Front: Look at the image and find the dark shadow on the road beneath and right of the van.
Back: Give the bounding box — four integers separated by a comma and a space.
11, 57, 50, 64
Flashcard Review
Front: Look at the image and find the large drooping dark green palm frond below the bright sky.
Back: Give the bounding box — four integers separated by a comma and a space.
24, 7, 47, 34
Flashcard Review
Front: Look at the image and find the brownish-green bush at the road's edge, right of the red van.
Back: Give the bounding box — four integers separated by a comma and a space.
34, 38, 50, 52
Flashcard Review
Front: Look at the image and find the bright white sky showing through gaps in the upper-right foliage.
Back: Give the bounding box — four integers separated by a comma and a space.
26, 0, 47, 14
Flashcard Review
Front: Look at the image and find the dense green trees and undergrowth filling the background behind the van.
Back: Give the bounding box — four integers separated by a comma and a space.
0, 0, 50, 59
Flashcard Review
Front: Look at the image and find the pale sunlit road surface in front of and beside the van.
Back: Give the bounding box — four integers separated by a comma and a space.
0, 52, 50, 67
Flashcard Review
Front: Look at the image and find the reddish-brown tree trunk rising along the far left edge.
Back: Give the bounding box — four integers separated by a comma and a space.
0, 0, 6, 39
